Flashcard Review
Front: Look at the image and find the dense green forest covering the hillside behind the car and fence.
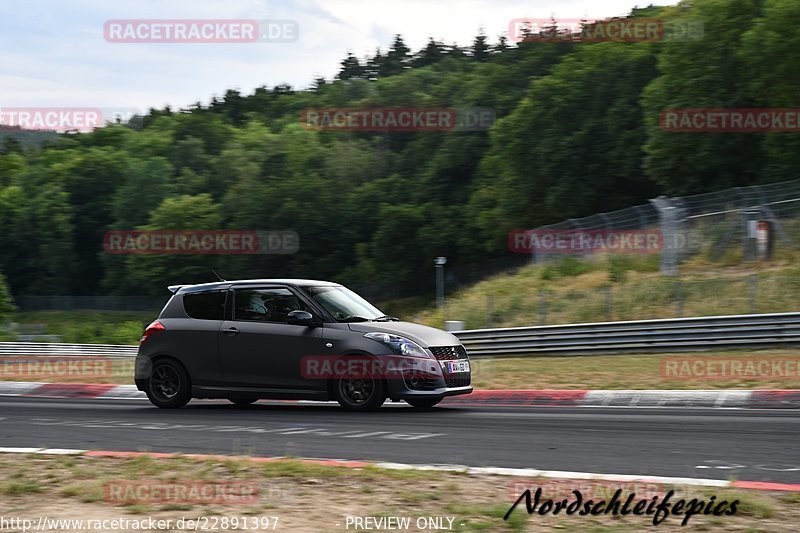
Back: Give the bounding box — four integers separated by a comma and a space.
0, 0, 800, 295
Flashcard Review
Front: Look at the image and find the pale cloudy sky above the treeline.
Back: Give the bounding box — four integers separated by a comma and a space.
0, 0, 677, 111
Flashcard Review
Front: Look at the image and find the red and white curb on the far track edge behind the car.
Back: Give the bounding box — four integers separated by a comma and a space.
0, 381, 800, 409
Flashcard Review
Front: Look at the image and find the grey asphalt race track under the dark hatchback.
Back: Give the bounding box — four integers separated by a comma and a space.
0, 397, 800, 483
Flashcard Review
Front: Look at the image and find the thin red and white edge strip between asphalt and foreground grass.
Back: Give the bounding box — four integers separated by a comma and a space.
0, 447, 800, 492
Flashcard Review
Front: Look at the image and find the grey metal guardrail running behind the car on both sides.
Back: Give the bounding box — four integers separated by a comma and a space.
0, 313, 800, 358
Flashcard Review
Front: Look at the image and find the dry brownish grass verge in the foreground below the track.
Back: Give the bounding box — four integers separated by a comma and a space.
0, 454, 800, 533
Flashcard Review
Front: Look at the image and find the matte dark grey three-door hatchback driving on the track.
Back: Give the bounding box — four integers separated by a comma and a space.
135, 279, 472, 410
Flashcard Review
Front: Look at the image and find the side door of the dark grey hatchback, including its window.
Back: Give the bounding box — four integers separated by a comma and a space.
219, 286, 325, 390
